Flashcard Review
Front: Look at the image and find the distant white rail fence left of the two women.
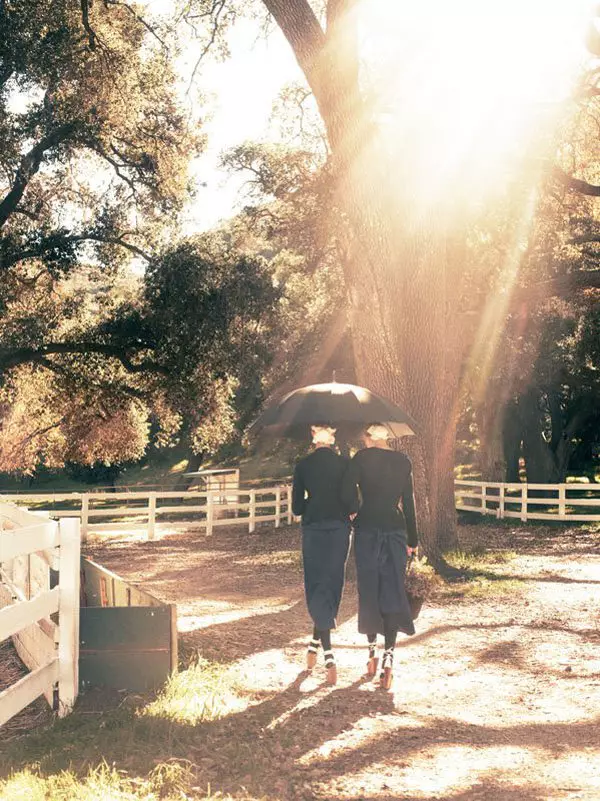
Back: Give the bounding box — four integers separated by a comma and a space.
0, 484, 294, 541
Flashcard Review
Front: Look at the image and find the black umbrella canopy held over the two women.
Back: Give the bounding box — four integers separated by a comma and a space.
248, 381, 417, 437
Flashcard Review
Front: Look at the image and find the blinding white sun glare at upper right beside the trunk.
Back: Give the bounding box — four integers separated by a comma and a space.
358, 0, 589, 206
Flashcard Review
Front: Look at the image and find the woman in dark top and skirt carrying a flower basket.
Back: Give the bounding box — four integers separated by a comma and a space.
343, 424, 417, 689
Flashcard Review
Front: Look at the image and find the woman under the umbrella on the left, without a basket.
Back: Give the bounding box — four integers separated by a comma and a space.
292, 426, 350, 684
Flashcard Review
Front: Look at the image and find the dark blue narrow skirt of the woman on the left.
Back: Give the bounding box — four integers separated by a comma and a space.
302, 520, 350, 630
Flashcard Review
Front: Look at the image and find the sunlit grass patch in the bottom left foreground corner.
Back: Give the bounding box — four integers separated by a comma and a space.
0, 659, 247, 801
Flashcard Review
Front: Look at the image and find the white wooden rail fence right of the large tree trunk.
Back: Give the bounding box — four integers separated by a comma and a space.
455, 481, 600, 522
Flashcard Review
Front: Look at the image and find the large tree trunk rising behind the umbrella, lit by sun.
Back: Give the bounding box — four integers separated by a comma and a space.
264, 0, 463, 562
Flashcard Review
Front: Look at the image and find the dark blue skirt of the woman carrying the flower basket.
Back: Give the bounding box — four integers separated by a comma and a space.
354, 526, 415, 634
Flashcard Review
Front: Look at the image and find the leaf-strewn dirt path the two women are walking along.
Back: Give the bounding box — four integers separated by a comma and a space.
85, 525, 600, 801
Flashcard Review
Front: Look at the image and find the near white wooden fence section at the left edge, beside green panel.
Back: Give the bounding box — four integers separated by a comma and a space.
0, 502, 80, 726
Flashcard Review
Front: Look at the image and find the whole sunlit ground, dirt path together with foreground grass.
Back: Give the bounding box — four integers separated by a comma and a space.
0, 526, 600, 801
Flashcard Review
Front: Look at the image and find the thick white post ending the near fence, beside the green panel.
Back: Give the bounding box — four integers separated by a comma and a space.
57, 517, 81, 717
